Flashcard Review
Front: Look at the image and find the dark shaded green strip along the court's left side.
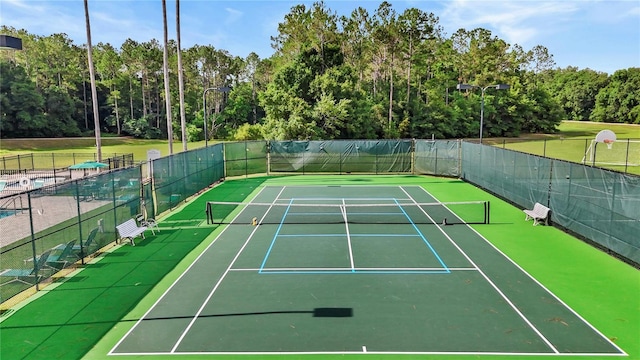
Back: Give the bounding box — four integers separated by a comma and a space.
0, 178, 266, 359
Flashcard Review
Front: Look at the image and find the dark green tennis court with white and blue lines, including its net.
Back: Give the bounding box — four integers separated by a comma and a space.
109, 185, 626, 356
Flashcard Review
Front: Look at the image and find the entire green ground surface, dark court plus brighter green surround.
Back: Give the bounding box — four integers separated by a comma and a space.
0, 175, 640, 359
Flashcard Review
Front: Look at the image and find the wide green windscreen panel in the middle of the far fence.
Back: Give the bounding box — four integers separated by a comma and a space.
269, 140, 413, 174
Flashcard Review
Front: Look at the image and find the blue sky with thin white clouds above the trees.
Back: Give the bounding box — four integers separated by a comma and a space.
0, 0, 640, 74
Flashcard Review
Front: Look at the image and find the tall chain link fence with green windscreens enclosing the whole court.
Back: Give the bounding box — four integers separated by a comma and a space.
0, 140, 640, 302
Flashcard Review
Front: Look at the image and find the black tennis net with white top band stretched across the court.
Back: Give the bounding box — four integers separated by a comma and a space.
205, 199, 490, 225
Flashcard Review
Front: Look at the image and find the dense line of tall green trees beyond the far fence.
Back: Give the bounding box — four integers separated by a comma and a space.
0, 1, 640, 141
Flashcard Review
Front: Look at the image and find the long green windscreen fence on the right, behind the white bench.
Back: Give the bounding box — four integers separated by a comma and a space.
461, 142, 640, 263
